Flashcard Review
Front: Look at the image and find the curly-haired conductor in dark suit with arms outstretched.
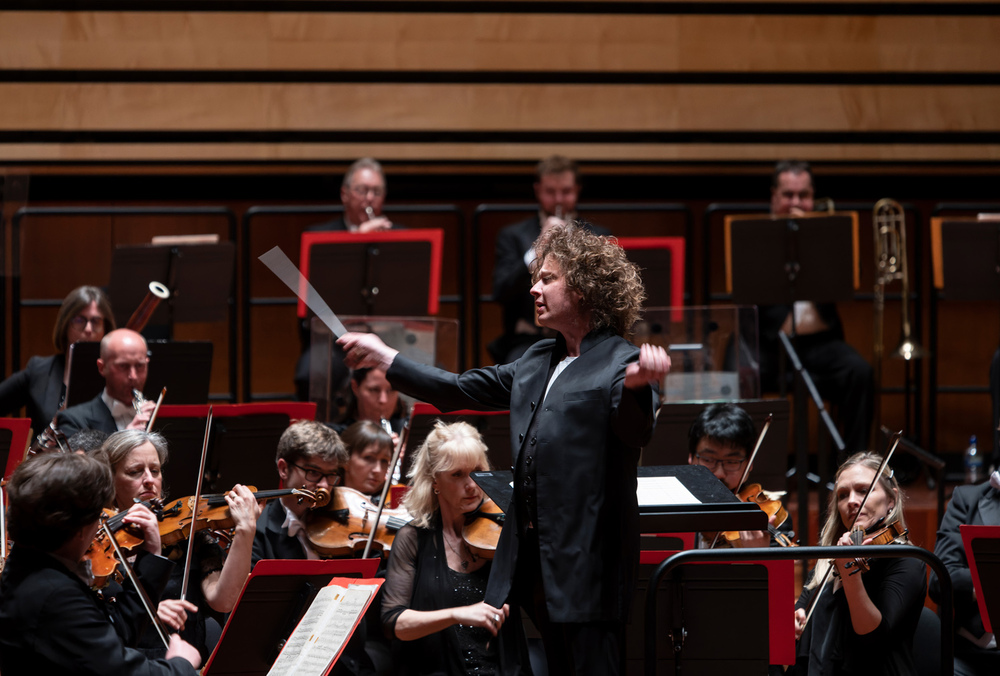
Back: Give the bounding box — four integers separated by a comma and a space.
338, 224, 670, 674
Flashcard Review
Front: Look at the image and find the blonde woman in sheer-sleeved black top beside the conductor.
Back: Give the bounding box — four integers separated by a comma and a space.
382, 422, 510, 674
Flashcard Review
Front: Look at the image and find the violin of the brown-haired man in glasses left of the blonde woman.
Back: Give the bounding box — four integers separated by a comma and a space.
305, 486, 410, 558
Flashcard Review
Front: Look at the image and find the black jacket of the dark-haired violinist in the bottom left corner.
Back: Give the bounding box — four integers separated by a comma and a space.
0, 546, 197, 676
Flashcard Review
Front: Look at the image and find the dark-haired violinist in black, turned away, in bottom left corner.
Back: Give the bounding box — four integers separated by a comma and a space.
0, 453, 201, 676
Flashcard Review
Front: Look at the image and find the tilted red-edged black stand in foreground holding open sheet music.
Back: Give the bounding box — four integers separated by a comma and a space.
202, 559, 383, 676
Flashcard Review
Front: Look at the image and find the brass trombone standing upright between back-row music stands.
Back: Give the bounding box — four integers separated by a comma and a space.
872, 198, 927, 436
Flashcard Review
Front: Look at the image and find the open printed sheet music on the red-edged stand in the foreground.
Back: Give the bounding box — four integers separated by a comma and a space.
267, 584, 378, 676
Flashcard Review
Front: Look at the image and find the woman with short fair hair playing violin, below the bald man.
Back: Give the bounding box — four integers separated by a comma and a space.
96, 430, 260, 659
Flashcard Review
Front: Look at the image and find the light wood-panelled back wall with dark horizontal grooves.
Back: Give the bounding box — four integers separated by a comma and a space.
0, 6, 1000, 162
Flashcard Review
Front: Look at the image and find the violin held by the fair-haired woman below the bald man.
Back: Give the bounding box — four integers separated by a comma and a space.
157, 486, 330, 547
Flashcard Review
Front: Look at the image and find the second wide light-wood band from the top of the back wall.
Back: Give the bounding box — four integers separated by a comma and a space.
0, 83, 1000, 132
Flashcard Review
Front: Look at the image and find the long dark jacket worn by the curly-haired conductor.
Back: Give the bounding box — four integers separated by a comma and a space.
387, 331, 659, 622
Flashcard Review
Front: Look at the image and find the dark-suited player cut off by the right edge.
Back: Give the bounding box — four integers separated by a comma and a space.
929, 472, 1000, 676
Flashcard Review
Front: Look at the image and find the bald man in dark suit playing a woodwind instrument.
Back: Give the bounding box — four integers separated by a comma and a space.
56, 329, 156, 437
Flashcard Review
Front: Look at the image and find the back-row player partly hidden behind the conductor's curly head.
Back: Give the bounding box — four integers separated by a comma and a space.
489, 155, 610, 364
